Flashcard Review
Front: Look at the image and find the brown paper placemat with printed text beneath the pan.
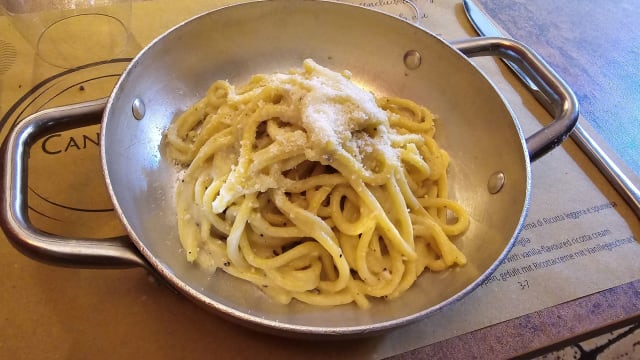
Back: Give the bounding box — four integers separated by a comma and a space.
0, 0, 640, 359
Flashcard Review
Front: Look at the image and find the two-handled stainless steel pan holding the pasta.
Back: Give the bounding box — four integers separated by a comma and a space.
1, 0, 577, 337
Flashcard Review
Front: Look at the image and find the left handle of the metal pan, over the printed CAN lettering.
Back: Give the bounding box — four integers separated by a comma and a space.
0, 99, 150, 269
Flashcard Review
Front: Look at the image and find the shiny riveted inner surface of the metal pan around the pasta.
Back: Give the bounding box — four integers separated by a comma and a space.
102, 1, 530, 334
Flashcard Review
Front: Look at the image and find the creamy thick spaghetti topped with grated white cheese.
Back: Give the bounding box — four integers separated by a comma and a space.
165, 59, 469, 308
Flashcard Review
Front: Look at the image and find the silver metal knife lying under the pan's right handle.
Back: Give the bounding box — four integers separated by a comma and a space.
462, 0, 640, 217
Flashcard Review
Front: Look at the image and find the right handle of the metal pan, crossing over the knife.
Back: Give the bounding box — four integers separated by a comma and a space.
452, 37, 578, 161
